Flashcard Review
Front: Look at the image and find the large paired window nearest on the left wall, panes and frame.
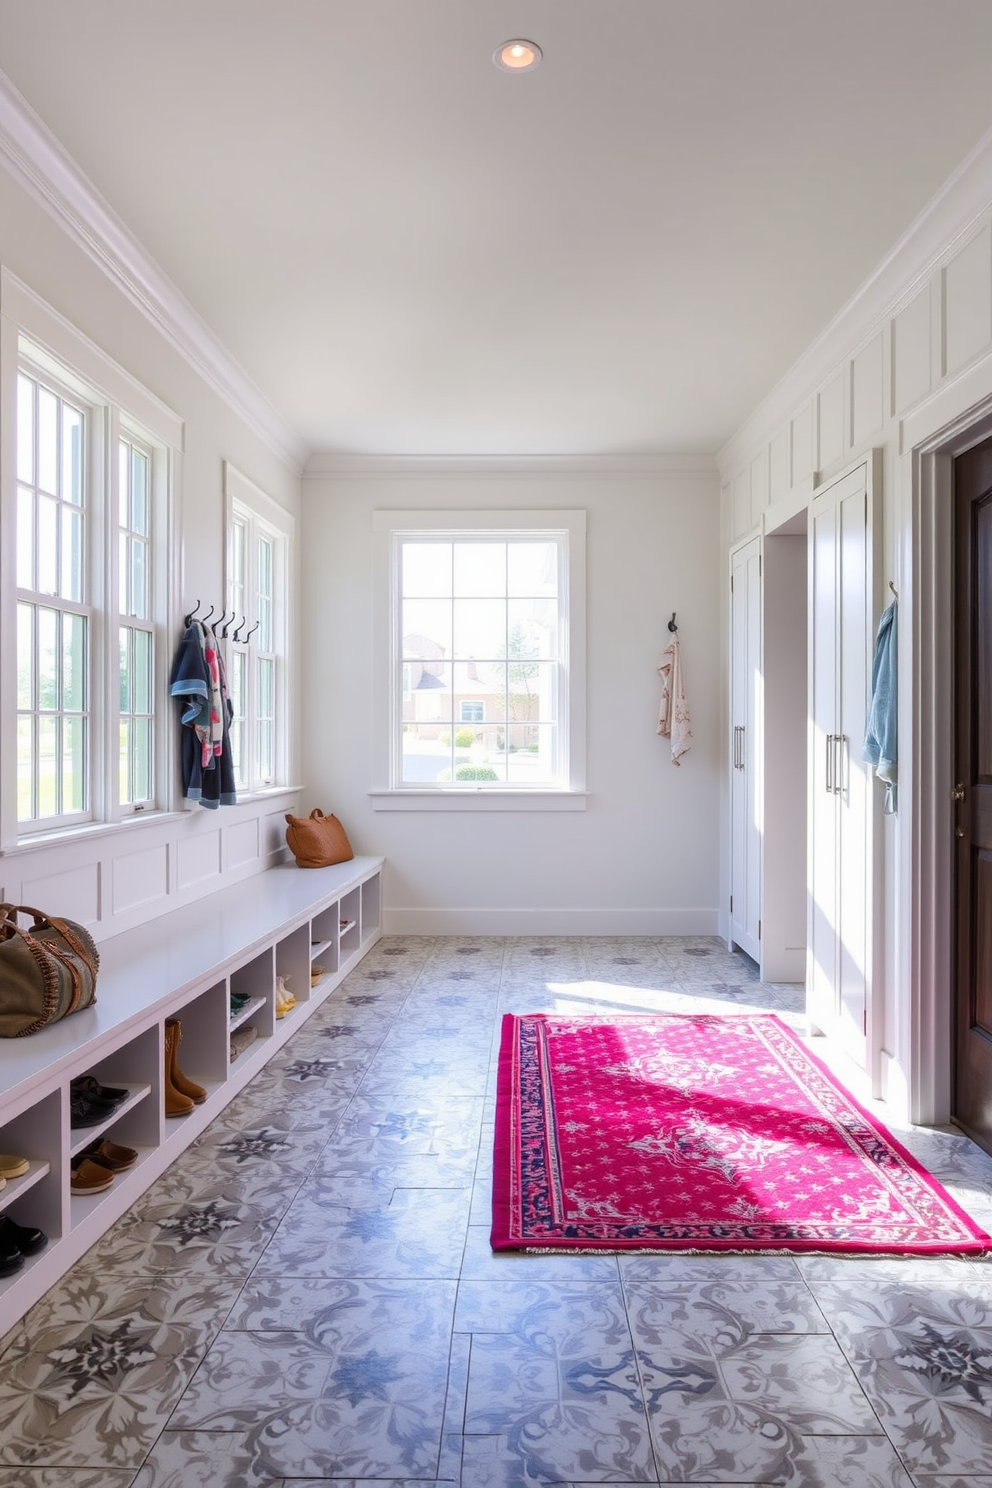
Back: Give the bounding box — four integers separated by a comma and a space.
0, 274, 181, 848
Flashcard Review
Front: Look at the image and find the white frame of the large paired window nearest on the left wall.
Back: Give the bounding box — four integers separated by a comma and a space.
0, 269, 183, 853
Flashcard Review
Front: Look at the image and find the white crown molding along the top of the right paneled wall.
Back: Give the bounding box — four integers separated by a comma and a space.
717, 118, 992, 475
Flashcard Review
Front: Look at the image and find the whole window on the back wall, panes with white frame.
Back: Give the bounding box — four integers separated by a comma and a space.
373, 512, 584, 809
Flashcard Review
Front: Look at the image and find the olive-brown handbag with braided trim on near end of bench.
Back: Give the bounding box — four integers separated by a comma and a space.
0, 905, 100, 1039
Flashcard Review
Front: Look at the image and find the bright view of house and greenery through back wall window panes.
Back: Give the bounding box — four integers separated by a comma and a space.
396, 533, 567, 789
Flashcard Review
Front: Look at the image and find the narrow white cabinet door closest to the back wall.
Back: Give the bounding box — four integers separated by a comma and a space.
730, 537, 763, 961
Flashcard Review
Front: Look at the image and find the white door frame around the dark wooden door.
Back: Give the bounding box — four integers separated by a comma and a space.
904, 377, 992, 1126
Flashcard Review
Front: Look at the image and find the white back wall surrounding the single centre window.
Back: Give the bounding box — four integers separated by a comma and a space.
302, 460, 721, 934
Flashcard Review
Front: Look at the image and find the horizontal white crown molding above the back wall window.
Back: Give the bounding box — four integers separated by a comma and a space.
303, 452, 718, 482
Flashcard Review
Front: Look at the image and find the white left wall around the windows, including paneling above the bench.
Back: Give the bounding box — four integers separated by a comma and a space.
0, 159, 300, 939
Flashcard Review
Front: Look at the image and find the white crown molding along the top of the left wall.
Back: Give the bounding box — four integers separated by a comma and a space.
0, 73, 309, 475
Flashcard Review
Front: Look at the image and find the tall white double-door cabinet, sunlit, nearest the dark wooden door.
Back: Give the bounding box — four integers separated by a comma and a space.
806, 461, 876, 1067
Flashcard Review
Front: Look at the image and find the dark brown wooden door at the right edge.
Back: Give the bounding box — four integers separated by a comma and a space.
953, 440, 992, 1152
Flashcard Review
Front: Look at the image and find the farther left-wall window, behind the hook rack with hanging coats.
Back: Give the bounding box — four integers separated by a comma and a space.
225, 464, 293, 792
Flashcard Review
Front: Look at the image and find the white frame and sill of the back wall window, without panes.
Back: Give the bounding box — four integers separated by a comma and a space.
369, 509, 587, 811
